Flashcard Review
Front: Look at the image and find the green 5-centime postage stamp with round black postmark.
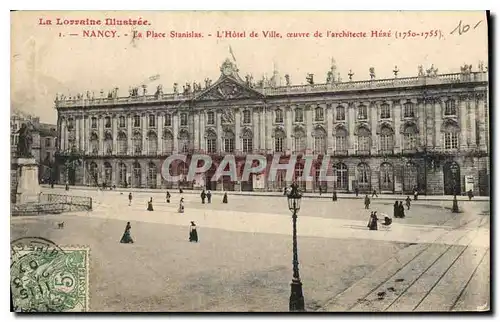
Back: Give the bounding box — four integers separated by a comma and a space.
10, 237, 90, 312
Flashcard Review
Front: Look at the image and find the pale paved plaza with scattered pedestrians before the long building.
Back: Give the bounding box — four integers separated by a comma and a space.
11, 188, 490, 311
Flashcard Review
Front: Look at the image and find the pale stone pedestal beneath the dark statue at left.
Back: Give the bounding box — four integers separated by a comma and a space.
16, 158, 41, 204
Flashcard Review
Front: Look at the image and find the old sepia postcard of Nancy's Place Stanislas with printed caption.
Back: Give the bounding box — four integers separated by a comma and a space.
10, 11, 491, 312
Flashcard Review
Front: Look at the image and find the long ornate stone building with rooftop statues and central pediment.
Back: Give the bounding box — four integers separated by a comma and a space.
55, 60, 490, 195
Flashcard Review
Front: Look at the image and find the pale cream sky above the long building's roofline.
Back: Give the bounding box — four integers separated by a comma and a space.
11, 11, 488, 123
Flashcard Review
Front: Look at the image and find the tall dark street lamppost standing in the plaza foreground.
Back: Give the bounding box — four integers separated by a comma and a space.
287, 182, 305, 312
